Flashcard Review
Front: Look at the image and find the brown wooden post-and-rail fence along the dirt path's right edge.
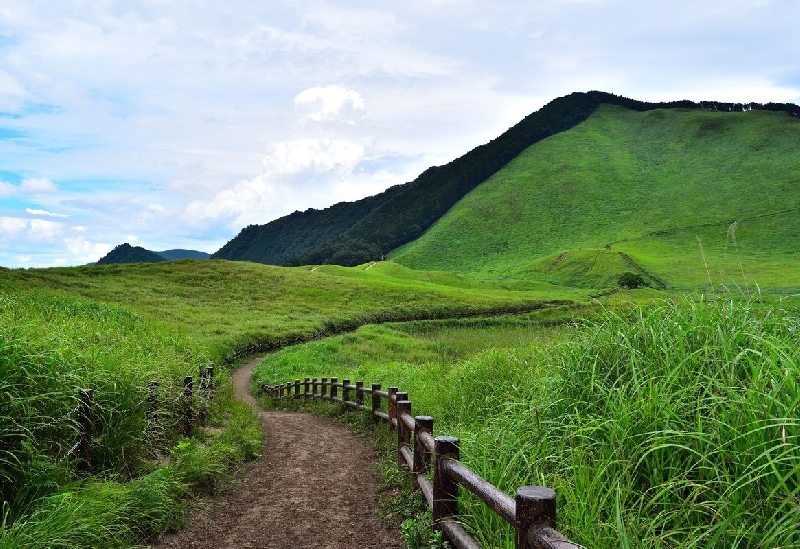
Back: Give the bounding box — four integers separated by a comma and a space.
261, 377, 581, 549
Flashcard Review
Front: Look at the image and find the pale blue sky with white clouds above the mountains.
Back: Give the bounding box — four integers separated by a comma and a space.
0, 0, 800, 268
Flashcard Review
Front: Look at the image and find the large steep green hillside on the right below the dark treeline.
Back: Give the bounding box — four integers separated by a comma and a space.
392, 105, 800, 289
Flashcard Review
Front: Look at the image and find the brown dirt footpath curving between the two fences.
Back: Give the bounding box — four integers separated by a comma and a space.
152, 360, 403, 549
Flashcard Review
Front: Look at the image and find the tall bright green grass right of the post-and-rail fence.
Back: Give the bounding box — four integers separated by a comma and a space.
260, 301, 800, 548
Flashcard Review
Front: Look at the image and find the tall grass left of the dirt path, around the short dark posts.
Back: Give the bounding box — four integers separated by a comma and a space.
0, 291, 260, 549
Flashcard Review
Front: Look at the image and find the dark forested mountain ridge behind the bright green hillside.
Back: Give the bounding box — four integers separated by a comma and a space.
212, 91, 800, 266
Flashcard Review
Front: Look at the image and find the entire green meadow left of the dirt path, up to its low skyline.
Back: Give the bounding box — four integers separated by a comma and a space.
0, 261, 582, 549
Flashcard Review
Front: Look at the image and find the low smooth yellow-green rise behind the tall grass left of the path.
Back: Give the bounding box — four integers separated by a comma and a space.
0, 260, 587, 360
